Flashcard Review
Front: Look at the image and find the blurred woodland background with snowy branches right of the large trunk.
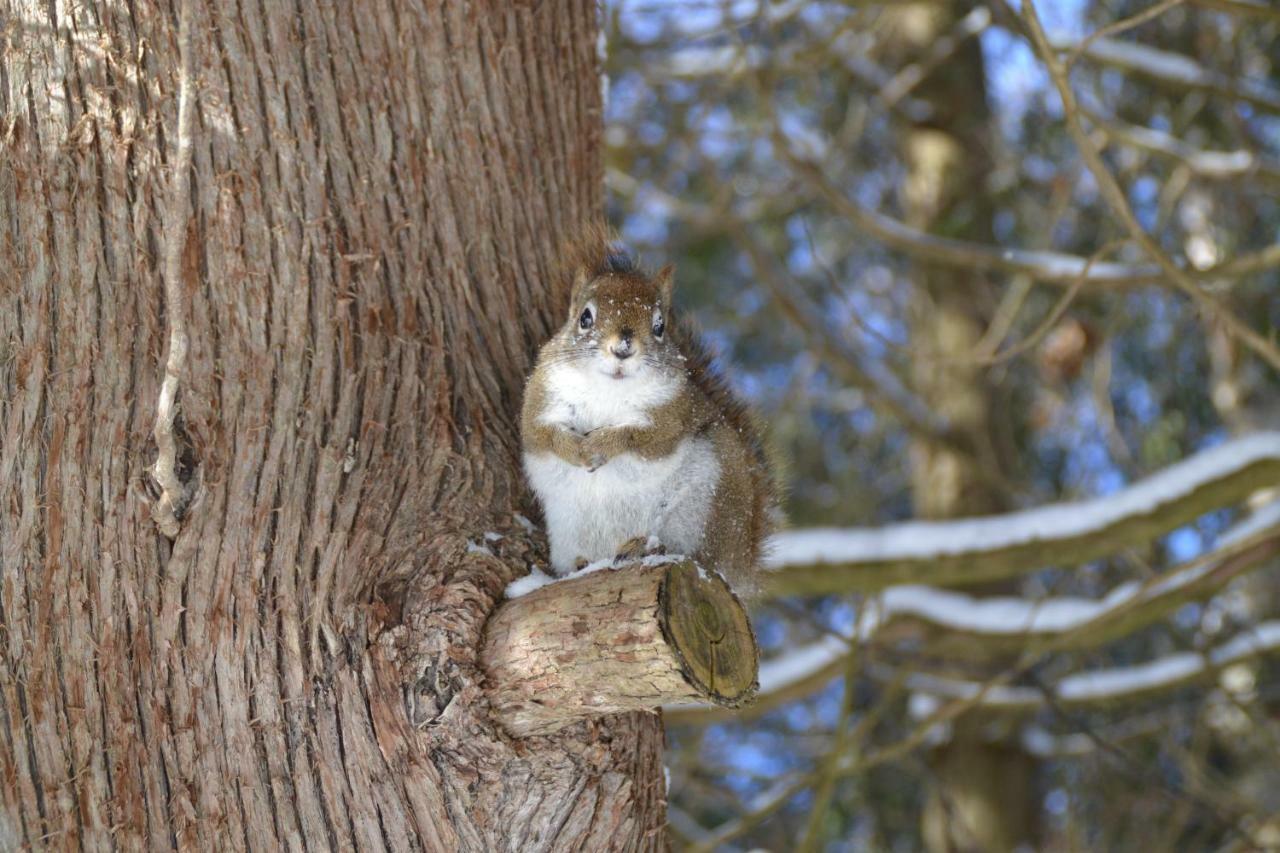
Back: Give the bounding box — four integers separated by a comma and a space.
605, 0, 1280, 850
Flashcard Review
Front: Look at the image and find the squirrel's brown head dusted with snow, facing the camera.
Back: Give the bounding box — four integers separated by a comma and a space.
556, 230, 681, 379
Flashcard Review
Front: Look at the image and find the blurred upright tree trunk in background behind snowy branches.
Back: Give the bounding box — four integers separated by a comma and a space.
892, 0, 1038, 852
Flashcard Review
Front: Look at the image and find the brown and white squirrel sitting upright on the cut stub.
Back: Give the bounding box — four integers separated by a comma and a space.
521, 228, 777, 596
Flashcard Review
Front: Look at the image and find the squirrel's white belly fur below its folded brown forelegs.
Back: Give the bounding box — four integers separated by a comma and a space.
525, 438, 721, 575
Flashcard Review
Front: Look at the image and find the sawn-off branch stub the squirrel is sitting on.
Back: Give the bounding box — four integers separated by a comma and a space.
480, 558, 759, 736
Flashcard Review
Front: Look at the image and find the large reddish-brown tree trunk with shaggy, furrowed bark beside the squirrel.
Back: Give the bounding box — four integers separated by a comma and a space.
0, 0, 664, 850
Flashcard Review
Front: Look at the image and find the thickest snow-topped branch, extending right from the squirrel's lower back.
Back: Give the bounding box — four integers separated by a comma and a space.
765, 433, 1280, 596
